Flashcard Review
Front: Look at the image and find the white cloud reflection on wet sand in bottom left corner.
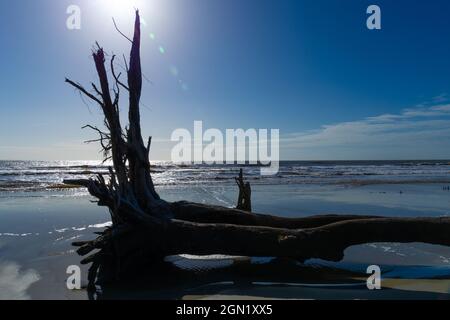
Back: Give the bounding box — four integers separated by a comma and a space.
0, 260, 40, 300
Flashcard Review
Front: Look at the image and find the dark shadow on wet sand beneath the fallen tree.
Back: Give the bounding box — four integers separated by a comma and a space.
89, 259, 450, 300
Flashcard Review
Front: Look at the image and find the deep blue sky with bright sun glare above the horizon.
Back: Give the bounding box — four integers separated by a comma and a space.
0, 0, 450, 159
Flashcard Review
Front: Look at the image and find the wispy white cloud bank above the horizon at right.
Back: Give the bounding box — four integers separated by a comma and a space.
281, 104, 450, 160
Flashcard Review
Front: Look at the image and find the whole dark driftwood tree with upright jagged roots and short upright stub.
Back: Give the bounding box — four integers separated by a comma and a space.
66, 12, 450, 281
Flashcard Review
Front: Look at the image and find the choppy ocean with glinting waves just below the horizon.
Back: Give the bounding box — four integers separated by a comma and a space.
0, 160, 450, 192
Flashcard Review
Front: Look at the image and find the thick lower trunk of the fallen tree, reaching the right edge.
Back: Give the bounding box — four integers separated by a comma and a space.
123, 218, 450, 261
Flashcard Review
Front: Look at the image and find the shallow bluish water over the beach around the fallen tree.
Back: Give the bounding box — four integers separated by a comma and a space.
0, 184, 450, 299
